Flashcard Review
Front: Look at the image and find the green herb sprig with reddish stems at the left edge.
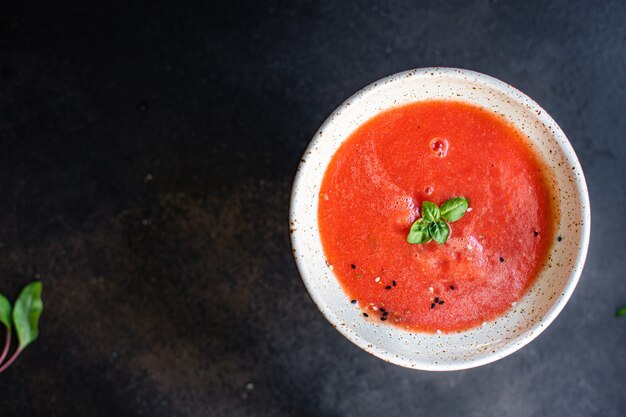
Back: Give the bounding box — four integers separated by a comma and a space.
0, 281, 43, 373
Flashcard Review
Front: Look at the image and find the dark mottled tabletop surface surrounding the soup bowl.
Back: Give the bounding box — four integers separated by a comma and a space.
0, 0, 626, 417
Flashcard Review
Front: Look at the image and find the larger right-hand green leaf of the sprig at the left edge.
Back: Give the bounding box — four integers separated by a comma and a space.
13, 281, 43, 350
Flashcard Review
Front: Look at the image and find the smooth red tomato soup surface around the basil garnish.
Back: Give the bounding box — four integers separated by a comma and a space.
318, 101, 556, 332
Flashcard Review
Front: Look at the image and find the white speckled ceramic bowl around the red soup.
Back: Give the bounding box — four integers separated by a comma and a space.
290, 68, 591, 371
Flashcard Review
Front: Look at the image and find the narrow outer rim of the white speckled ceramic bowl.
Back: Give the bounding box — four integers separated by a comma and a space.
289, 67, 591, 371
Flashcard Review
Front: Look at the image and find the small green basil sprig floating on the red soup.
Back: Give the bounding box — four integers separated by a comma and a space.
406, 197, 468, 244
